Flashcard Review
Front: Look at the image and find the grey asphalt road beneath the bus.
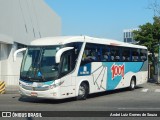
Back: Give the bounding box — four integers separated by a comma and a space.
0, 83, 160, 120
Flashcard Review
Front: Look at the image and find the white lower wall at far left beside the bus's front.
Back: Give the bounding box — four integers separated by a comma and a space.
0, 43, 22, 85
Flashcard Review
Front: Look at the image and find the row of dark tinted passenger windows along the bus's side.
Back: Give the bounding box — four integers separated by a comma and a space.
82, 43, 147, 63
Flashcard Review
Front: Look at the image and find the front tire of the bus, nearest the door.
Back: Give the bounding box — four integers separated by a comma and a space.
77, 82, 89, 100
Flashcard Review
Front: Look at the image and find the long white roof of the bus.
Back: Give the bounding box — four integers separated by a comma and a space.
30, 36, 147, 49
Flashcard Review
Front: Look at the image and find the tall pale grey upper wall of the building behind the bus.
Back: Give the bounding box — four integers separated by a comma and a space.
0, 0, 61, 44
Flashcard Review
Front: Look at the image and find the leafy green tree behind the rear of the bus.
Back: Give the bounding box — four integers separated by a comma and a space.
133, 16, 160, 71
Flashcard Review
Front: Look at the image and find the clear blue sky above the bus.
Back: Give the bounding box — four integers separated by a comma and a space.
45, 0, 160, 41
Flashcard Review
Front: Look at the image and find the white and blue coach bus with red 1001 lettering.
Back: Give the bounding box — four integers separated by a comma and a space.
14, 36, 148, 100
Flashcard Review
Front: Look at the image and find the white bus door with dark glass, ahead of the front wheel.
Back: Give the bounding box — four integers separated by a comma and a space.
60, 50, 75, 96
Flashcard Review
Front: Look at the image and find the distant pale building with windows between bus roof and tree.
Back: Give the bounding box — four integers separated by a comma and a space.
123, 28, 138, 44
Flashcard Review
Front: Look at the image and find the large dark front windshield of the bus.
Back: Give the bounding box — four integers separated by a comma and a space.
20, 46, 60, 82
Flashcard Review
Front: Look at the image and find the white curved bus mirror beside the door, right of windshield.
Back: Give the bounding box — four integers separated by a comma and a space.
56, 47, 74, 63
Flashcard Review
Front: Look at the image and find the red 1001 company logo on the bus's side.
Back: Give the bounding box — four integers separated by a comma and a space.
111, 63, 125, 80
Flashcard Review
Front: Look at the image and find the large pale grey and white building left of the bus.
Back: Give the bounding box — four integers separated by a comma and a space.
0, 0, 61, 86
